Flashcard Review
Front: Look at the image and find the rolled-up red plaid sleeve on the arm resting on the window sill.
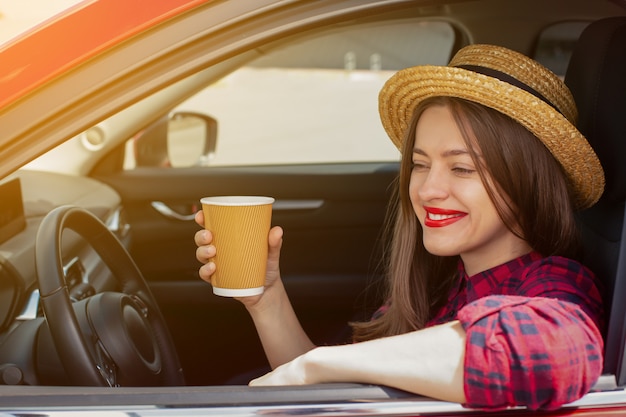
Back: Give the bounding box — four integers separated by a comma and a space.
458, 296, 603, 410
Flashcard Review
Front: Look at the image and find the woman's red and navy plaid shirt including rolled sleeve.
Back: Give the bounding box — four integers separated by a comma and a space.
372, 252, 603, 409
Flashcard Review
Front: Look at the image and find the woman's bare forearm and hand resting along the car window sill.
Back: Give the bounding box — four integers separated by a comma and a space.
250, 321, 465, 403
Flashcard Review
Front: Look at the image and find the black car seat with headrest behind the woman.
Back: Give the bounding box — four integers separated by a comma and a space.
565, 16, 626, 386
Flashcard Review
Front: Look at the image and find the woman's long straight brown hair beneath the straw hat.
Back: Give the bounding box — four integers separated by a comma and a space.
352, 97, 580, 341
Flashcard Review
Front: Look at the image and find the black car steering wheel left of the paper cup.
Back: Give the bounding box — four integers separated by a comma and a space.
35, 206, 185, 386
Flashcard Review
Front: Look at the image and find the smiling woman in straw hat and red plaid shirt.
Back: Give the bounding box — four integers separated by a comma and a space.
195, 45, 604, 409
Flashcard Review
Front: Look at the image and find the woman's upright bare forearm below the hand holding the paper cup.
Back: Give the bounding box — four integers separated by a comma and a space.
247, 279, 315, 369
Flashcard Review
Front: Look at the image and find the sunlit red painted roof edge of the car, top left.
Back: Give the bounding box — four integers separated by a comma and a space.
0, 0, 208, 108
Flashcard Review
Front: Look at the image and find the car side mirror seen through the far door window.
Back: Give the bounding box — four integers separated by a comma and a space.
134, 112, 217, 168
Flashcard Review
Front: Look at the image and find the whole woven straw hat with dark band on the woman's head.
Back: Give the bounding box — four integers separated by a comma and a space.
379, 45, 604, 209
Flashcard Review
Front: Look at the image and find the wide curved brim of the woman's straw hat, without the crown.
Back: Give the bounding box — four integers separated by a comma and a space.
379, 65, 604, 209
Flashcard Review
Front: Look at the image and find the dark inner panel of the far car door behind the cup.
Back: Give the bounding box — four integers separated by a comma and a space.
98, 163, 397, 385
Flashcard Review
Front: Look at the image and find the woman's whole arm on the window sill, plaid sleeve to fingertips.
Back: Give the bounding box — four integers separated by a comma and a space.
250, 296, 603, 409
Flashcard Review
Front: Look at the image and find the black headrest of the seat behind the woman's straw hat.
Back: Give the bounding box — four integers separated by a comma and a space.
565, 16, 626, 202
